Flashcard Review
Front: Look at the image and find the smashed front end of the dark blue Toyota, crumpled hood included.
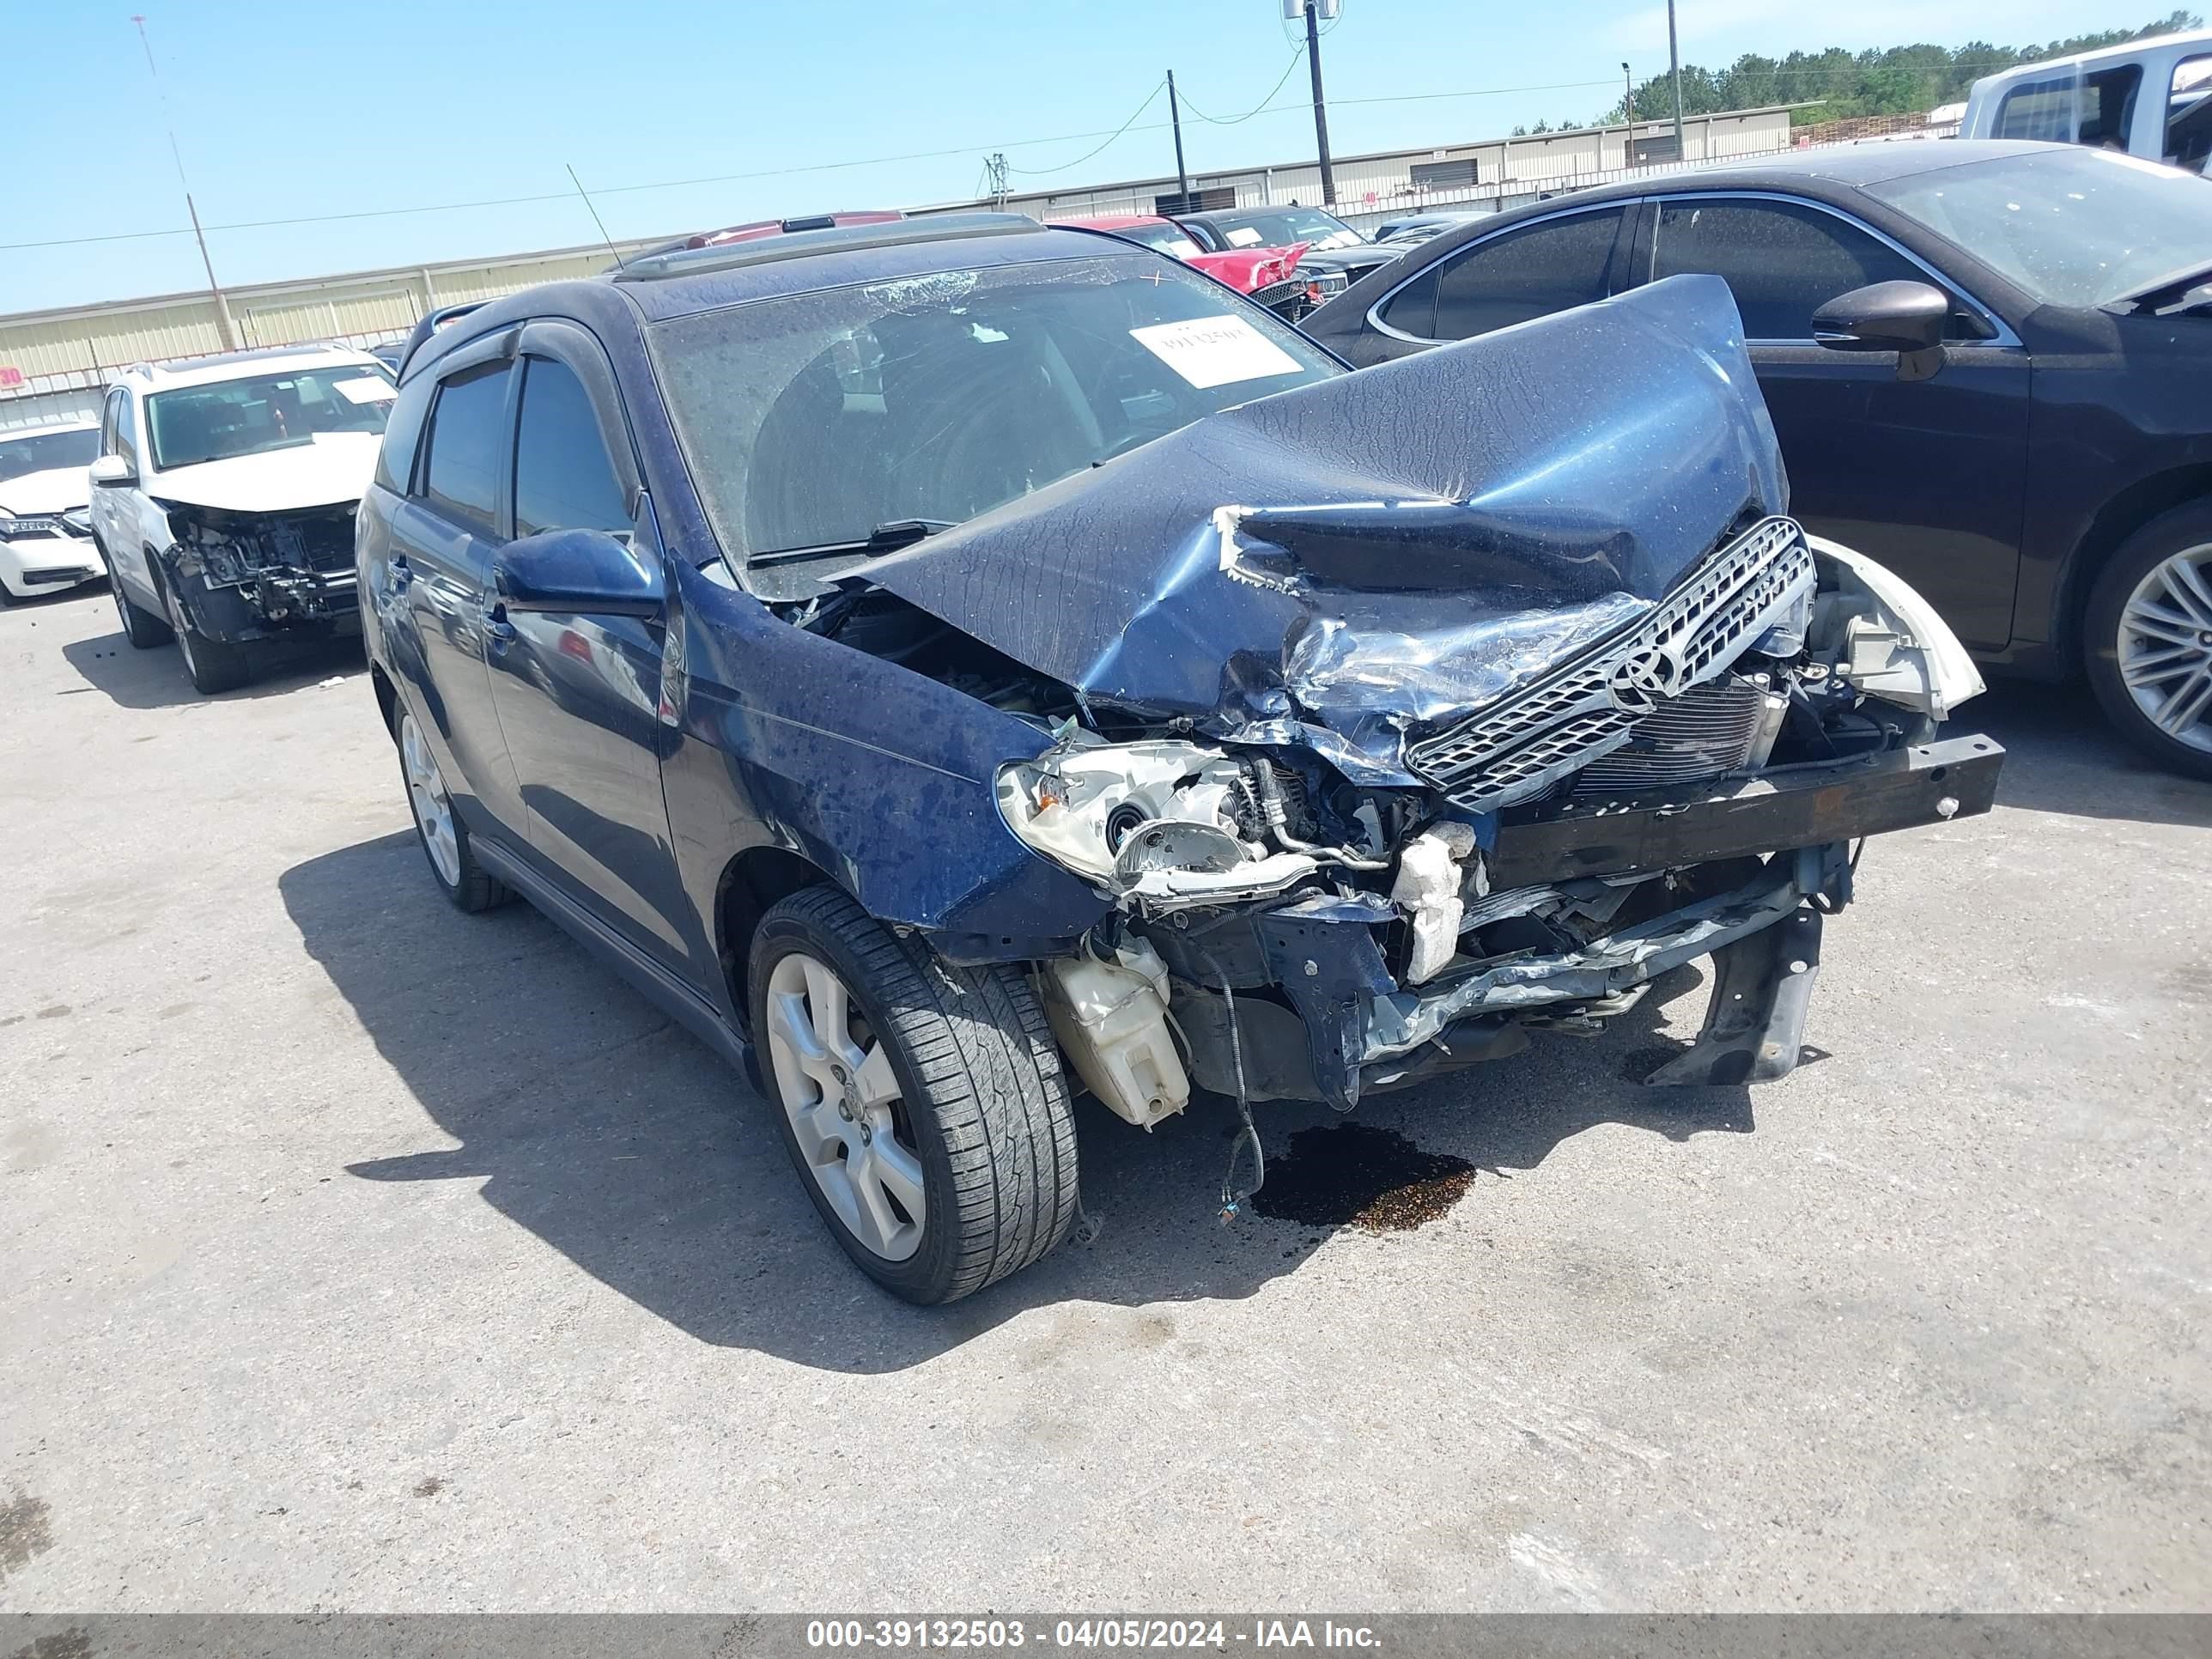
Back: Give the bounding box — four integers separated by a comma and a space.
792, 276, 2002, 1194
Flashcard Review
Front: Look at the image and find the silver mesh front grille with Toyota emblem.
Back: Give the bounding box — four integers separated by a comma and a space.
1407, 518, 1814, 811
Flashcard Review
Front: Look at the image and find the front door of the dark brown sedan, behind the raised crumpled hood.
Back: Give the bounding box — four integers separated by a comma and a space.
1650, 192, 2028, 650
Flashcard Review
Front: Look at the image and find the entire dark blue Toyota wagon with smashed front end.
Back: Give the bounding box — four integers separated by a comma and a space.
358, 215, 2002, 1303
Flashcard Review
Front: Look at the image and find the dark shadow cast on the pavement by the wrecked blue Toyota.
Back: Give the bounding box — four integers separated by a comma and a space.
279, 832, 1752, 1371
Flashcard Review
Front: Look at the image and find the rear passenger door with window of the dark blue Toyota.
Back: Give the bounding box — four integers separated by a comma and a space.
389, 330, 529, 831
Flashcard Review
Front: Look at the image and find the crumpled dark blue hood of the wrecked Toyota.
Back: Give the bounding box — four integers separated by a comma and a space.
848, 276, 1787, 785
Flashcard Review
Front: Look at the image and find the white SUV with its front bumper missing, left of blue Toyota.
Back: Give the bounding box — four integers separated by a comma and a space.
91, 345, 394, 692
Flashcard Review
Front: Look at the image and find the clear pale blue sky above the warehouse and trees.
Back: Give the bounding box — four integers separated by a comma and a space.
0, 0, 2172, 312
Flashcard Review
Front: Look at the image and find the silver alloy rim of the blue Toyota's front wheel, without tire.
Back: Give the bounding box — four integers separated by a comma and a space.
765, 951, 927, 1261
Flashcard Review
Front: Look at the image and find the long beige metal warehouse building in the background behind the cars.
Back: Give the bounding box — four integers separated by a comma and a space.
0, 106, 1792, 429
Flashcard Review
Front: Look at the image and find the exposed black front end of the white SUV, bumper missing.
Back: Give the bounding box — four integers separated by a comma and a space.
161, 502, 361, 644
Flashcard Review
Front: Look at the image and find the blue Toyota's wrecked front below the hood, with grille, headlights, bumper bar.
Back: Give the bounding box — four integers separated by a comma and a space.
1000, 518, 2002, 1124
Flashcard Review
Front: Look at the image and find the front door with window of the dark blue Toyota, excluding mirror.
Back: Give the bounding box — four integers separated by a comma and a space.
487, 321, 699, 980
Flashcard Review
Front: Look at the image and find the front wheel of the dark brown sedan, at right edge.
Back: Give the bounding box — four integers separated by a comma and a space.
2086, 502, 2212, 779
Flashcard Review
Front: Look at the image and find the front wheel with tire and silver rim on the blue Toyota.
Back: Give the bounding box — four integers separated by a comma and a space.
752, 887, 1078, 1303
